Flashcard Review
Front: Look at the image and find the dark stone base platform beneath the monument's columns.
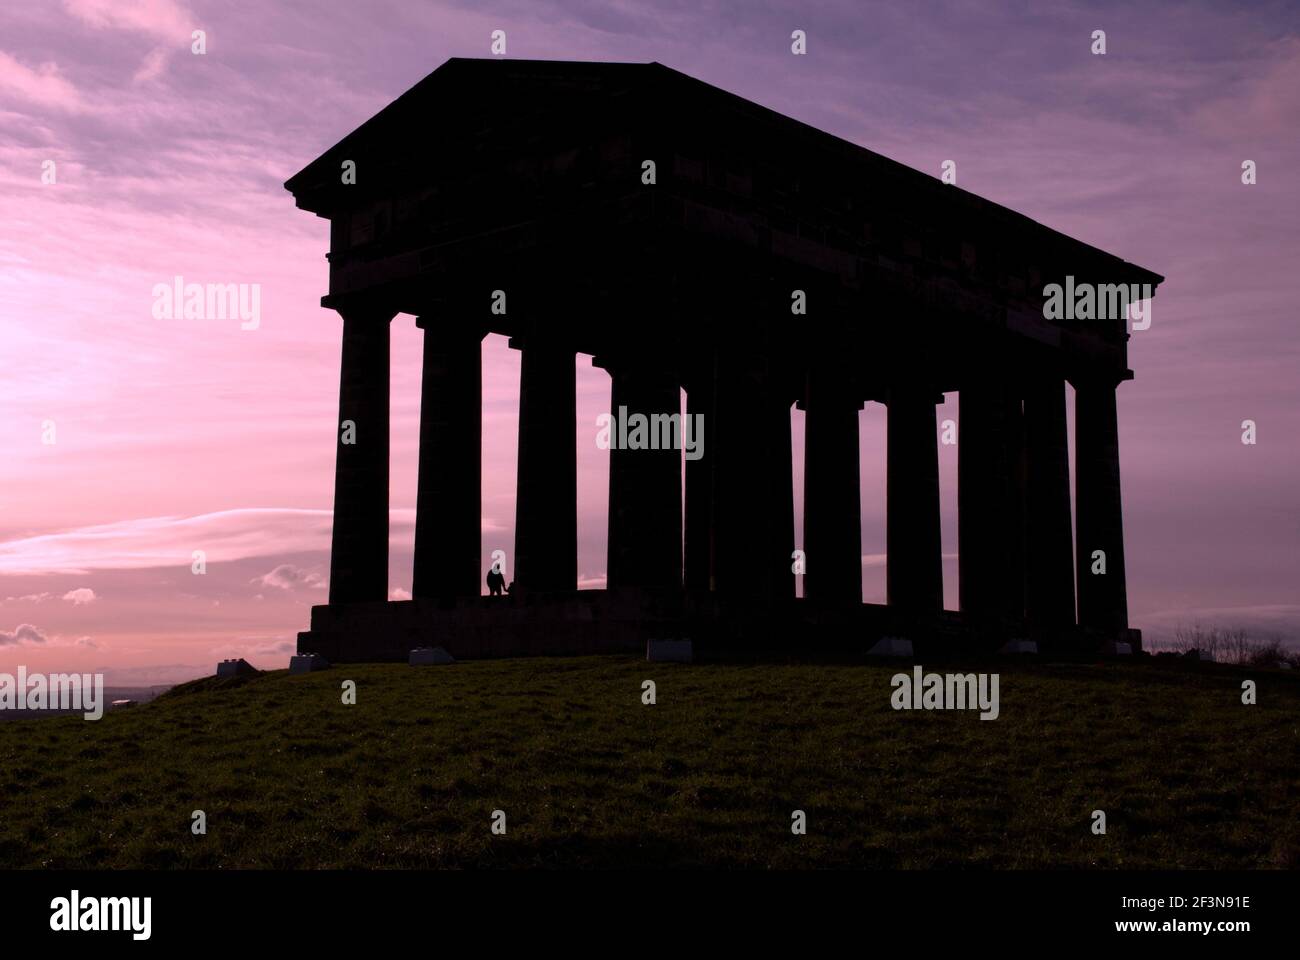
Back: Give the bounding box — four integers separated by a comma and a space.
298, 589, 1141, 663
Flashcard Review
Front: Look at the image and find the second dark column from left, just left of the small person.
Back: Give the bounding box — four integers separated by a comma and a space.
411, 317, 485, 597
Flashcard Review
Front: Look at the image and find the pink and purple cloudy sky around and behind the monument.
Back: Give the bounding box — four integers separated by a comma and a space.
0, 0, 1300, 683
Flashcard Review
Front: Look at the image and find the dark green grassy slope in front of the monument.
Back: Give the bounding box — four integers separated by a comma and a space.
0, 657, 1300, 868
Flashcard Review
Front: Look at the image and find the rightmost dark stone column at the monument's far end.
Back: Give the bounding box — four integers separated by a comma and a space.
1074, 376, 1128, 630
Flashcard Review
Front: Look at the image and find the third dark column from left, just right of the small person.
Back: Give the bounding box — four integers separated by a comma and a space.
507, 336, 577, 591
